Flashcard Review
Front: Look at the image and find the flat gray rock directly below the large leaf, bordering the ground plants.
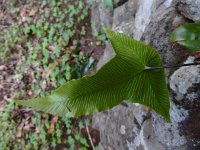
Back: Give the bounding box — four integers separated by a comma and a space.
93, 103, 143, 150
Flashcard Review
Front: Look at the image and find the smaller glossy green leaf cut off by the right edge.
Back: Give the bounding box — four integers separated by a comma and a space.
171, 23, 200, 52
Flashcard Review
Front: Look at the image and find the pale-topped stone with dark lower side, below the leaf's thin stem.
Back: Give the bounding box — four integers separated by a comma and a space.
170, 56, 200, 148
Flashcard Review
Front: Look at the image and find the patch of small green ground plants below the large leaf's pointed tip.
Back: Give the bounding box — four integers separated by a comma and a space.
0, 102, 90, 150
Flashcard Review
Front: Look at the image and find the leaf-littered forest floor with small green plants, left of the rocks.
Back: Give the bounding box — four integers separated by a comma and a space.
0, 0, 105, 150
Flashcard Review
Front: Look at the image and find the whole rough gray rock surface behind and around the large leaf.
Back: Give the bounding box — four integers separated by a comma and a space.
92, 0, 200, 150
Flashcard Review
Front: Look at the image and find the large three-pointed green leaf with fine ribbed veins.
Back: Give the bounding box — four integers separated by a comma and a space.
16, 29, 170, 121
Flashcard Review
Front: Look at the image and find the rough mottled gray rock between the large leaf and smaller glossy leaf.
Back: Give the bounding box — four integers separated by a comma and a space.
141, 2, 188, 74
